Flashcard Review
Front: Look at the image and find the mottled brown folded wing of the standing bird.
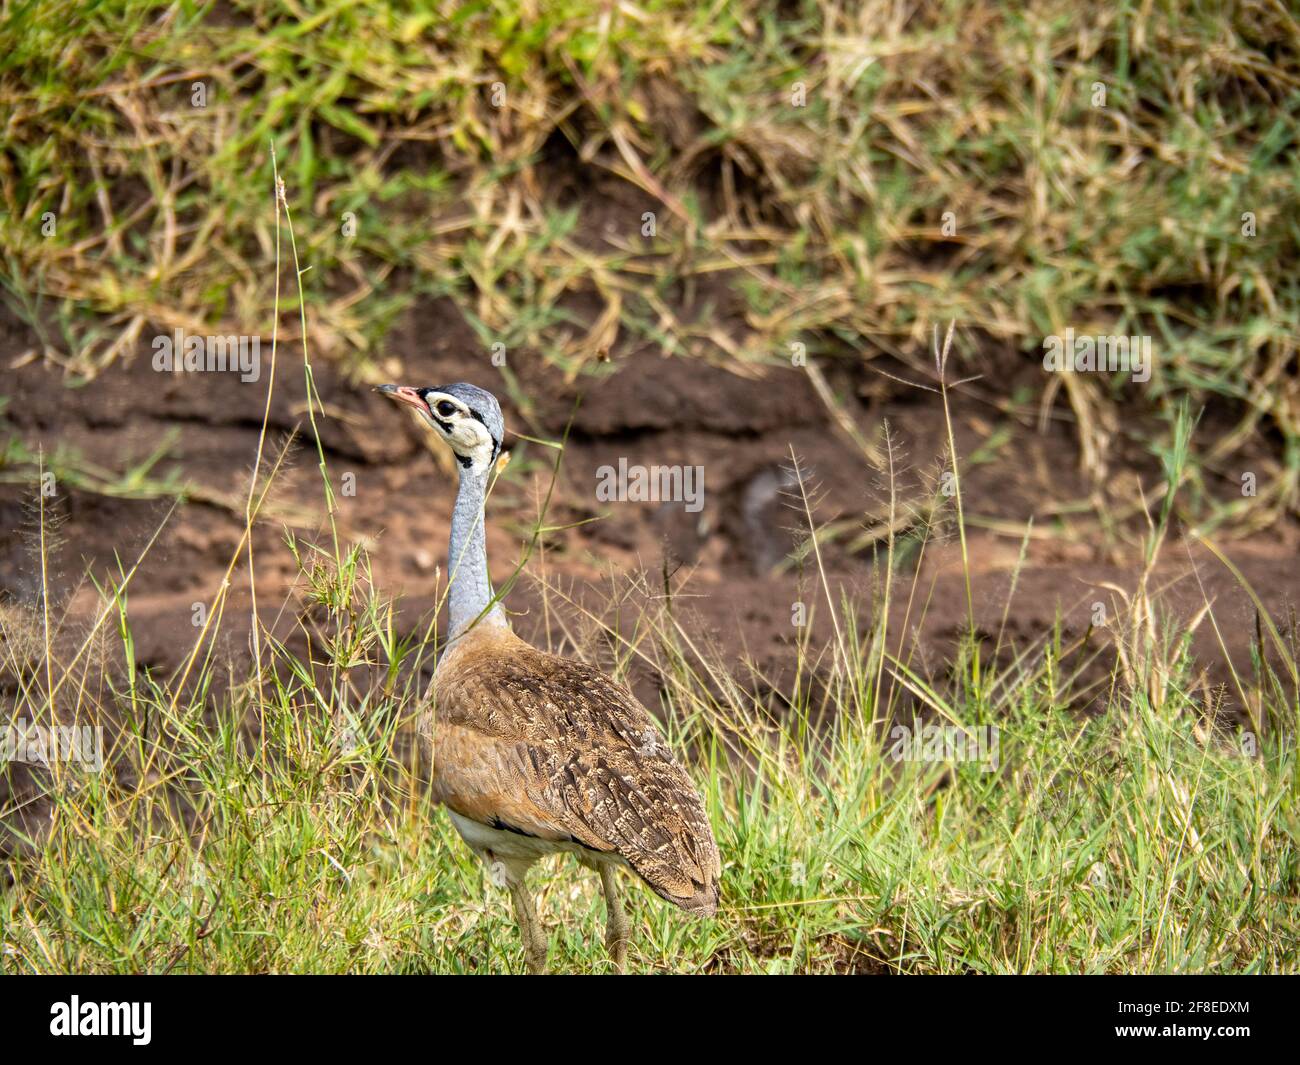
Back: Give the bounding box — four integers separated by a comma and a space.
433, 629, 720, 914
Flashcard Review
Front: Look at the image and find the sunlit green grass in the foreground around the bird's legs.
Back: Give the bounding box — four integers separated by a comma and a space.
0, 496, 1300, 973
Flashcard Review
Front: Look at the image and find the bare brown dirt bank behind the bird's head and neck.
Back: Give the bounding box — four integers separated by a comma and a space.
0, 304, 1300, 723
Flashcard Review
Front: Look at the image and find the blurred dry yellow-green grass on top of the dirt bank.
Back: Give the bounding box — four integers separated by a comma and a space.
0, 0, 1300, 501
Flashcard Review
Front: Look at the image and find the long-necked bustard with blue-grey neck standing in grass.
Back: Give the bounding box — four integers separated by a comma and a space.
378, 382, 722, 973
